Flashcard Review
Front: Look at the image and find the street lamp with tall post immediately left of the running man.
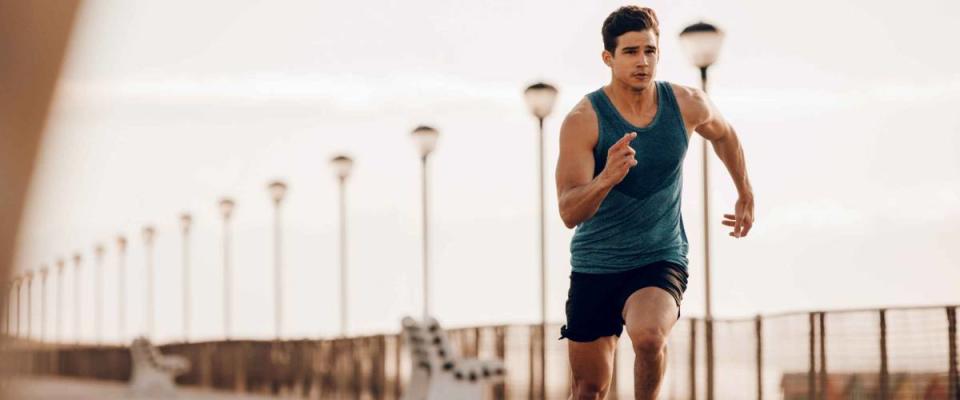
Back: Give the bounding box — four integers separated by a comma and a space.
523, 82, 557, 398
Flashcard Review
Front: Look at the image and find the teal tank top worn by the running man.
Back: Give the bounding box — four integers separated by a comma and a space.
570, 82, 689, 274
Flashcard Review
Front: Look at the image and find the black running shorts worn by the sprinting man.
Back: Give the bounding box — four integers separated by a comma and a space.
560, 261, 687, 342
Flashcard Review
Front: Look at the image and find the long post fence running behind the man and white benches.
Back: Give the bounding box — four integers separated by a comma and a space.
2, 306, 960, 400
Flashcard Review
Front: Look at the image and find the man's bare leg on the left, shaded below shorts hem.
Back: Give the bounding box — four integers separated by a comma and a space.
568, 336, 617, 400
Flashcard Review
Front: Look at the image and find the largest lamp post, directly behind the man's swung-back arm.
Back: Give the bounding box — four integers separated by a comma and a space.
680, 22, 723, 400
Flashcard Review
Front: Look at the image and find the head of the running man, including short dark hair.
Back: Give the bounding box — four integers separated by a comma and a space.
602, 6, 660, 89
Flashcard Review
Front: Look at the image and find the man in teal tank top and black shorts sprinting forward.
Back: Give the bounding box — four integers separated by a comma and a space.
556, 6, 753, 399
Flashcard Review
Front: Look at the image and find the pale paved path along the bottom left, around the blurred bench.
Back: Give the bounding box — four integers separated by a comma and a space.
0, 377, 278, 400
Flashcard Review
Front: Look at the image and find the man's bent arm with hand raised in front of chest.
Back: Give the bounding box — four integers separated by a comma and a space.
556, 99, 637, 228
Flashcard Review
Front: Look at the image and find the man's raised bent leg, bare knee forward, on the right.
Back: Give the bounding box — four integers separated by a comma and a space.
623, 286, 679, 400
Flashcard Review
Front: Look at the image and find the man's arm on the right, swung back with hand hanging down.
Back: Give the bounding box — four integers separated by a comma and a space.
689, 89, 753, 237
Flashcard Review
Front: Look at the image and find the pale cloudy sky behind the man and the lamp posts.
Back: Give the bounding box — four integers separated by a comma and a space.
9, 0, 960, 341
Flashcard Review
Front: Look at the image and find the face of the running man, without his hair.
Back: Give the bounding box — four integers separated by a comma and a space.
603, 29, 660, 90
